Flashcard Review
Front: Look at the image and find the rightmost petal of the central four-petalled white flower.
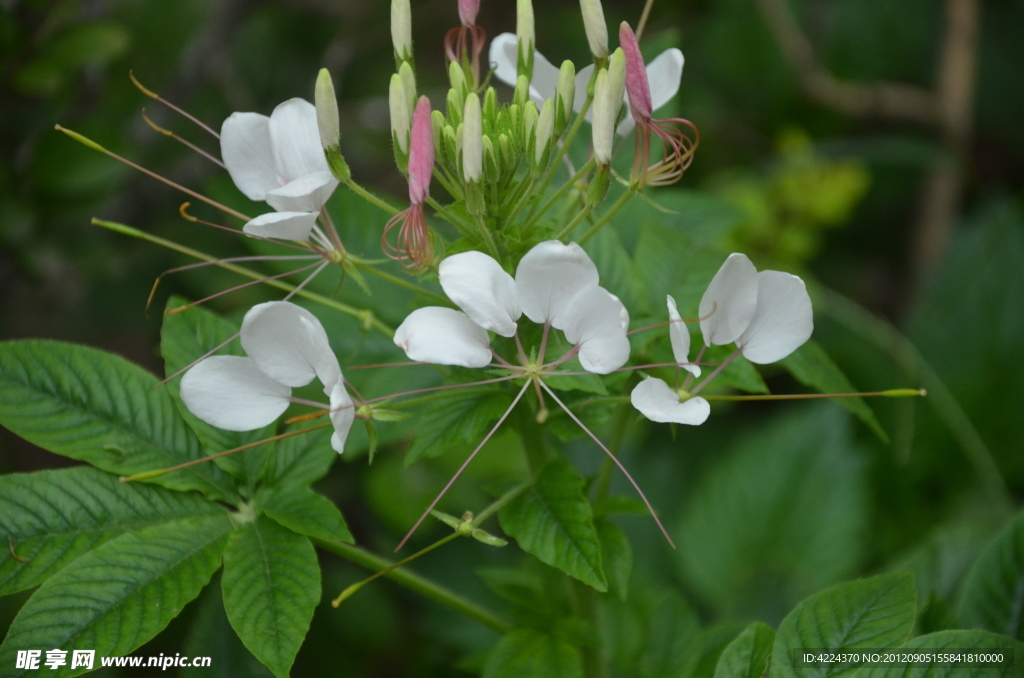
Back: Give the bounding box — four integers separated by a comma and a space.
563, 287, 630, 374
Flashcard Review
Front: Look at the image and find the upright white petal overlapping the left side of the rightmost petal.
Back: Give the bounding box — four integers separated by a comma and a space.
698, 254, 758, 346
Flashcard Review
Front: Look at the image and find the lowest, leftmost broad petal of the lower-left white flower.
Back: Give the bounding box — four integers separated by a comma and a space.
181, 355, 292, 431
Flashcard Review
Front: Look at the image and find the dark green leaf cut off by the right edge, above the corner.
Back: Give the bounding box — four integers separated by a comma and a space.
961, 512, 1024, 639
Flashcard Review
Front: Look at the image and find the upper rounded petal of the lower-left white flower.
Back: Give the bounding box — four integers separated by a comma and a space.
242, 301, 341, 394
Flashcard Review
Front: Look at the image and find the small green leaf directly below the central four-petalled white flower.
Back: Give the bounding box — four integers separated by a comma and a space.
406, 388, 512, 466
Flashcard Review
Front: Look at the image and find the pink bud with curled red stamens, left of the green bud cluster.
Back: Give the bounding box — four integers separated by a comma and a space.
381, 96, 434, 270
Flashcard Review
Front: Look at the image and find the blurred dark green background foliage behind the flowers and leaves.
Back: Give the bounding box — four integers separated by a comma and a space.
0, 0, 1024, 677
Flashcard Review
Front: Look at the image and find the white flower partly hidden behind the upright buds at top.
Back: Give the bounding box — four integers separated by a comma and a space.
489, 33, 684, 136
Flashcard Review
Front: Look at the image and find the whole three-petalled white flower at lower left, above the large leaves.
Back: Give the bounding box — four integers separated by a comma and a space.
181, 301, 355, 454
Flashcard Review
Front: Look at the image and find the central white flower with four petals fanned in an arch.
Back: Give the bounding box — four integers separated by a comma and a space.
394, 241, 630, 374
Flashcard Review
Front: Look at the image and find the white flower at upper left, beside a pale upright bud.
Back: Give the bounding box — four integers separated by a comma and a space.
220, 98, 338, 241
